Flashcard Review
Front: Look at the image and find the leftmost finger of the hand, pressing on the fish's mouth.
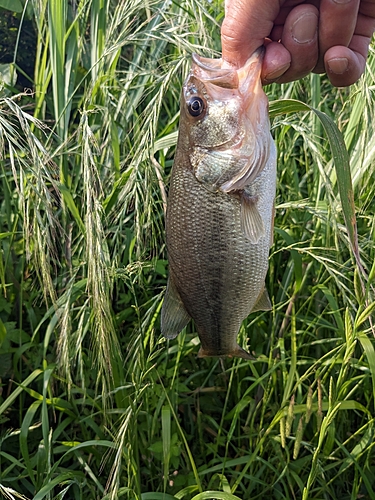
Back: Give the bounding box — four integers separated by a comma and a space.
221, 0, 282, 67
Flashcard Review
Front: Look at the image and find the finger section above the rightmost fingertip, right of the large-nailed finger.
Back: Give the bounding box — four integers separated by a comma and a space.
315, 0, 359, 73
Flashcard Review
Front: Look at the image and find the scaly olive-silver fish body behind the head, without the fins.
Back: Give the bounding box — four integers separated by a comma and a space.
166, 146, 276, 356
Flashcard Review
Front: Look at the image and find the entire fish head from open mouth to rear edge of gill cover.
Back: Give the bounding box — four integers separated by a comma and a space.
180, 49, 270, 192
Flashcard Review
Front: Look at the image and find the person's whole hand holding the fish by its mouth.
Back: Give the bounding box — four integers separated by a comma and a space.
221, 0, 375, 87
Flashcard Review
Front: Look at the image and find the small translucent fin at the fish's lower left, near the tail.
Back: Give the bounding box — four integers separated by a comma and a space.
161, 277, 190, 339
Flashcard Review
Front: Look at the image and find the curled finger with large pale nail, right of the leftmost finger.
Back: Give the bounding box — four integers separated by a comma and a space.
277, 4, 319, 83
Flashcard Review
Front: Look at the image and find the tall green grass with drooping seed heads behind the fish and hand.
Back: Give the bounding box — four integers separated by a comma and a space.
0, 0, 375, 500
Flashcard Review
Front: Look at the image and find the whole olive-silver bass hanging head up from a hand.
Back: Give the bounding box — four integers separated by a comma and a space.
161, 49, 276, 359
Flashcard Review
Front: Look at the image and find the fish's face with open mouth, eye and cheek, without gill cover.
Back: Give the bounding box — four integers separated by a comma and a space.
181, 50, 264, 148
